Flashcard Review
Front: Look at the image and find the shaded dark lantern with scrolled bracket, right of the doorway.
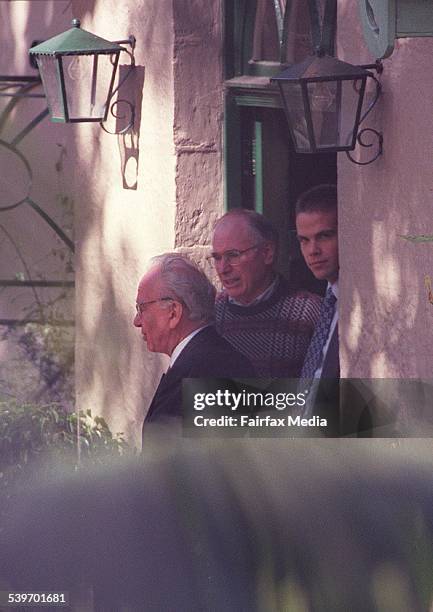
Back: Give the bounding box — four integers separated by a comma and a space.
271, 51, 383, 165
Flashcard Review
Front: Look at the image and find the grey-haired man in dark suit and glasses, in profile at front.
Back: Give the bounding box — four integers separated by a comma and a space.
134, 253, 255, 425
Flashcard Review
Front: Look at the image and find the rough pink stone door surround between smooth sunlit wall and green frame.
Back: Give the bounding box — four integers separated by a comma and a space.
173, 0, 223, 275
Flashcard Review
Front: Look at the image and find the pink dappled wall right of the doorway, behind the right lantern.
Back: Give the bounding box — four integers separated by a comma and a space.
338, 0, 433, 378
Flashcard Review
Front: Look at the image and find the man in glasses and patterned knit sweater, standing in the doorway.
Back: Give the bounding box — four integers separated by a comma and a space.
210, 209, 320, 378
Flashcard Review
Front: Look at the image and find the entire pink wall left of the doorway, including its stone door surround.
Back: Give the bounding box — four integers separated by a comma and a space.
0, 0, 223, 441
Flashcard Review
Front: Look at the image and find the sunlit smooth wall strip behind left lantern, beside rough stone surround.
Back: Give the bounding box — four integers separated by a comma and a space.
67, 0, 175, 442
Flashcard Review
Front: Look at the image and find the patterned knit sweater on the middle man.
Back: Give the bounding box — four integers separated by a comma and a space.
215, 277, 322, 378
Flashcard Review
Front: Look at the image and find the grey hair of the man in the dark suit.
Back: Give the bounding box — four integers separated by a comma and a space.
151, 253, 216, 323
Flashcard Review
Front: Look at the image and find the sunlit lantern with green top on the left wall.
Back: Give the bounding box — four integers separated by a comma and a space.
29, 19, 135, 123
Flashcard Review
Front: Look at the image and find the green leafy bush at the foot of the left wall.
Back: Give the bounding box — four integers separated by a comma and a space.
0, 402, 128, 516
